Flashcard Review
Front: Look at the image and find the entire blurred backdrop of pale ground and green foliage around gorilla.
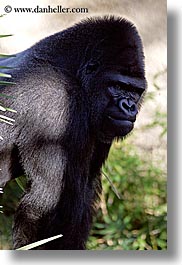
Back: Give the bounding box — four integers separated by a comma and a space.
0, 0, 167, 250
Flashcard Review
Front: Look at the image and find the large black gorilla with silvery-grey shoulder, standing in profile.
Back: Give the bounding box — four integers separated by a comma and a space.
0, 16, 147, 250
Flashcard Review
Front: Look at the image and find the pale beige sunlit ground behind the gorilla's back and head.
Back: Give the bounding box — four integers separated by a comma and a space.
0, 0, 167, 168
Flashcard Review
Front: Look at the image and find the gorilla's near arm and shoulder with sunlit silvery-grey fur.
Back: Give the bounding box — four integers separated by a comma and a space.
0, 59, 101, 249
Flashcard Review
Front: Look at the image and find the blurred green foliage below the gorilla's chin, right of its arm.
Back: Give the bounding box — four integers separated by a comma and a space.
88, 142, 167, 250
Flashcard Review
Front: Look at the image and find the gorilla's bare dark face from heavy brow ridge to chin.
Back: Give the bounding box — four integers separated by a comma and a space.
94, 71, 145, 142
